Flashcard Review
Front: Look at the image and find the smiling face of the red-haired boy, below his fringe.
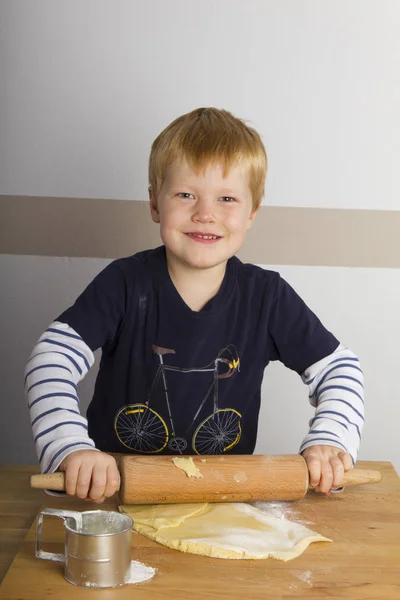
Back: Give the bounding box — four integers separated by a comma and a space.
149, 161, 255, 269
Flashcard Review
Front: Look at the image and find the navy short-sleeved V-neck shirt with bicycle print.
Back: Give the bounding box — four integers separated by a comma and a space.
57, 246, 339, 455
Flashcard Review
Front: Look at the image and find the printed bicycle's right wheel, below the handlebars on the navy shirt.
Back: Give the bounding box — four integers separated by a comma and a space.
192, 408, 242, 454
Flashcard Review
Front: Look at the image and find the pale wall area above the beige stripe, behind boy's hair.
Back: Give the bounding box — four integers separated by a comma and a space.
0, 0, 400, 210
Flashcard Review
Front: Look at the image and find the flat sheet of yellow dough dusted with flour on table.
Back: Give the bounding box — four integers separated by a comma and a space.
119, 502, 332, 561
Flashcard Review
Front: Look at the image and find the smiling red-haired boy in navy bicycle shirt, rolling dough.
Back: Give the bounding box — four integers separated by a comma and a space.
25, 108, 364, 503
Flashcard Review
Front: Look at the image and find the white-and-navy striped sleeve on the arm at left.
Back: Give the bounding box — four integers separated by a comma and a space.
25, 321, 99, 473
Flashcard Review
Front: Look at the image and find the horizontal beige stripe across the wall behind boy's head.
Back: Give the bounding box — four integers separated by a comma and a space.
0, 195, 400, 268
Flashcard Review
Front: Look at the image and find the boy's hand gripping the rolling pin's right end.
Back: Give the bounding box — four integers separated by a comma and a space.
301, 446, 353, 495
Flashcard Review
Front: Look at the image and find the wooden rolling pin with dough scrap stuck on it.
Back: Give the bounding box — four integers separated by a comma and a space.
31, 454, 382, 504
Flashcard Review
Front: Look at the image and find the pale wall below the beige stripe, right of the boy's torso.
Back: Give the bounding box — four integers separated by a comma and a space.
257, 265, 400, 472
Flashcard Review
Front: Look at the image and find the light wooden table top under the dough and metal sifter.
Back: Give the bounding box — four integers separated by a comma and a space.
0, 461, 400, 600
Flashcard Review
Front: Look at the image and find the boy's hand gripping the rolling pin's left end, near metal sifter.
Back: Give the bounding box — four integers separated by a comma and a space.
59, 450, 121, 504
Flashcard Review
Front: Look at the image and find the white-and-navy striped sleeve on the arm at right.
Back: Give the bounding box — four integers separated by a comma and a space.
299, 345, 364, 464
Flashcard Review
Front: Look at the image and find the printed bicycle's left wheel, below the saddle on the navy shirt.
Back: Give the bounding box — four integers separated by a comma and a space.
114, 404, 169, 454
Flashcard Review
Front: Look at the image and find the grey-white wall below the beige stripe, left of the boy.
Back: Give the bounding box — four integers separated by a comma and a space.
0, 254, 109, 464
